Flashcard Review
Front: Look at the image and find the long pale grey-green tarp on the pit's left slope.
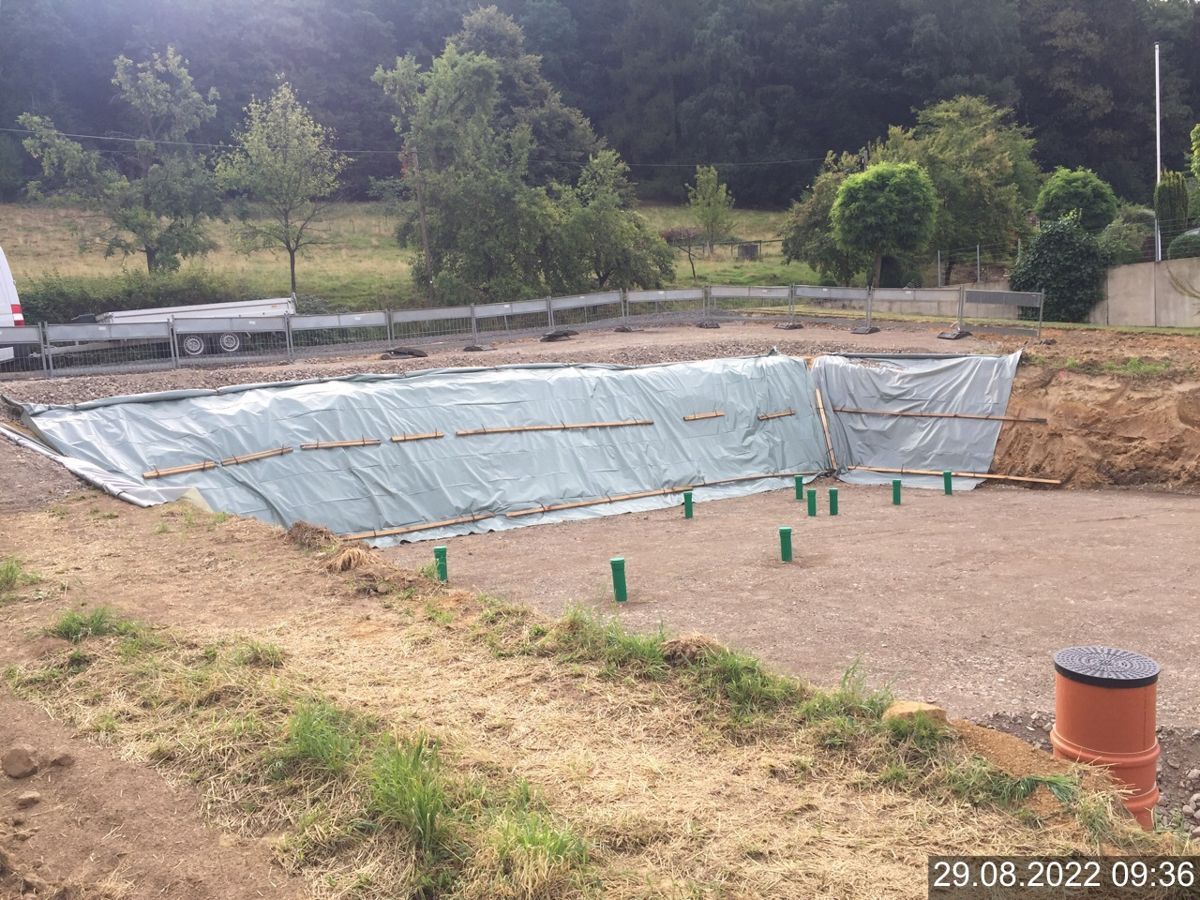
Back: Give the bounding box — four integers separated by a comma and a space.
11, 354, 827, 545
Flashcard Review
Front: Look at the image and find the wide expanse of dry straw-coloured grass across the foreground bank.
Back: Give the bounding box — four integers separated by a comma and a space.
2, 514, 1180, 899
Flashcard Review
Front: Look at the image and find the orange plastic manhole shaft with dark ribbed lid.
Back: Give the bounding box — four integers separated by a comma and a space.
1050, 647, 1159, 828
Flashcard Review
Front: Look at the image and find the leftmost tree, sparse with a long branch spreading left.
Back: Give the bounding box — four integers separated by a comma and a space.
18, 47, 221, 274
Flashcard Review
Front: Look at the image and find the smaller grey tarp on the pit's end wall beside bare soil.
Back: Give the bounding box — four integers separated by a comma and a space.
812, 353, 1021, 490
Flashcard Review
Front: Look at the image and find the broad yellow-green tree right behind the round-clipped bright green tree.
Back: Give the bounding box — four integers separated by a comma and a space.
874, 96, 1040, 283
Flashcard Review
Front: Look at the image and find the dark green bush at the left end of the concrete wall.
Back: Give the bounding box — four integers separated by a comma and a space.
1009, 211, 1105, 322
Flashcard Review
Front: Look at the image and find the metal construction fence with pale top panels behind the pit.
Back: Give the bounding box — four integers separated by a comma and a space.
0, 284, 1043, 379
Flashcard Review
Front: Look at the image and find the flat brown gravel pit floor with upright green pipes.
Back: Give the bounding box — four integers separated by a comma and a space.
388, 480, 1200, 726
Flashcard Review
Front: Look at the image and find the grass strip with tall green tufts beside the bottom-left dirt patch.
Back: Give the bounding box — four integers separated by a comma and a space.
6, 608, 594, 899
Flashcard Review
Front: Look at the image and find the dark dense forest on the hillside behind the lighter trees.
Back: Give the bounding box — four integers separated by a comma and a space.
0, 0, 1200, 206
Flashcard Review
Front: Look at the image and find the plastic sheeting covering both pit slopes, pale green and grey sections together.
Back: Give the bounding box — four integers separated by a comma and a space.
9, 354, 1018, 545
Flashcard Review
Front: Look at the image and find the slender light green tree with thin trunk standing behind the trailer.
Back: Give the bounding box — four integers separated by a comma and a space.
217, 82, 347, 294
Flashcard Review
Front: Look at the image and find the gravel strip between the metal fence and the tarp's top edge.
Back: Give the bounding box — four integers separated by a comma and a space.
0, 323, 994, 403
